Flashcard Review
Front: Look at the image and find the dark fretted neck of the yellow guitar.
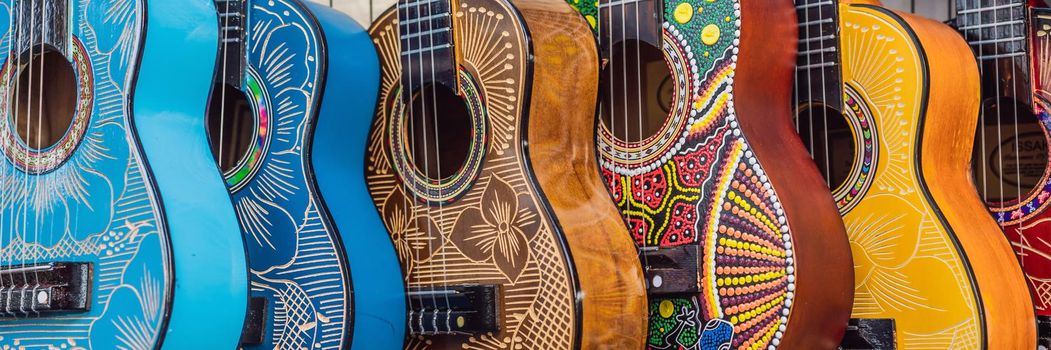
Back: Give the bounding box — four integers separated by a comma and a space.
796, 0, 843, 108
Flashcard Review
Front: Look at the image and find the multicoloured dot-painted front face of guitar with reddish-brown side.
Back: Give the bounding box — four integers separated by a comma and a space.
598, 0, 795, 349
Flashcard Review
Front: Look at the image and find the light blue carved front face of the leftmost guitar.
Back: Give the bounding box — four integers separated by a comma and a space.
0, 0, 172, 349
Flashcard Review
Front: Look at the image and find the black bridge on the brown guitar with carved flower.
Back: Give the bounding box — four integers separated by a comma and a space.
409, 285, 499, 335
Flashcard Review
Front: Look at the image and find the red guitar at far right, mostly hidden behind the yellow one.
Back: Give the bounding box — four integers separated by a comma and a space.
955, 0, 1051, 338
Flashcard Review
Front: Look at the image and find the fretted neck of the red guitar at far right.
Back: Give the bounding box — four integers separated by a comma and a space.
956, 0, 1032, 104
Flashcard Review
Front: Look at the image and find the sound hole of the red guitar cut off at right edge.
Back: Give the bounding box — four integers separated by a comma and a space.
972, 98, 1048, 203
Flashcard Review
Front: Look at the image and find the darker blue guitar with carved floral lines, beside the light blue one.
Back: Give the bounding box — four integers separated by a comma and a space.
208, 0, 405, 349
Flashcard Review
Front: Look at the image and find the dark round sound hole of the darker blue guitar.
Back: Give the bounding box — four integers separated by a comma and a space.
208, 84, 256, 173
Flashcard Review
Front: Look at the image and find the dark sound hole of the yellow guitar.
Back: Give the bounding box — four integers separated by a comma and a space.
796, 105, 858, 189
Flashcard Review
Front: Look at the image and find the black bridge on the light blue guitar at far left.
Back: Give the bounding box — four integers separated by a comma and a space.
0, 263, 92, 317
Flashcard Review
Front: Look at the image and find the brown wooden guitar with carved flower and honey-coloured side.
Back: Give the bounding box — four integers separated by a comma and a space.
366, 0, 646, 350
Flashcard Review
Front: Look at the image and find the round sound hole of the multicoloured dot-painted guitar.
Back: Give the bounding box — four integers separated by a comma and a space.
599, 40, 675, 143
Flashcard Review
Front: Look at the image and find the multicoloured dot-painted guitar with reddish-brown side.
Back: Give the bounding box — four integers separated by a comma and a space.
578, 0, 853, 350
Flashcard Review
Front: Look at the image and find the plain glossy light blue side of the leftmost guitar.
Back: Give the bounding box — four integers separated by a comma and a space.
138, 0, 248, 349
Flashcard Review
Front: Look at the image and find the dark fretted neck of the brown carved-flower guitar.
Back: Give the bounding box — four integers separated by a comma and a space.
397, 0, 458, 91
